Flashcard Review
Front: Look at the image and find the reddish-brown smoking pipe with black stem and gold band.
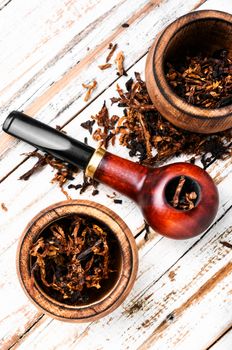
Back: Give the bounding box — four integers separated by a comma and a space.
3, 111, 218, 239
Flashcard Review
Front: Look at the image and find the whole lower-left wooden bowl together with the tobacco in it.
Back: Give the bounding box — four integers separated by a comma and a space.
17, 200, 138, 322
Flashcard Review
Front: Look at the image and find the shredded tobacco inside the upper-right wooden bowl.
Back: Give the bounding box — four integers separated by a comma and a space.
166, 49, 232, 108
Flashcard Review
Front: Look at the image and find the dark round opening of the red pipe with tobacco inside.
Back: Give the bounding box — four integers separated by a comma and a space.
166, 176, 198, 210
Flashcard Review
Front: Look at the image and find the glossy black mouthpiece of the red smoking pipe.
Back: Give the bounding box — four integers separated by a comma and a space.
3, 111, 95, 169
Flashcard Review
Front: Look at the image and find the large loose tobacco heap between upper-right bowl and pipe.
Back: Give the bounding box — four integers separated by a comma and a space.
88, 72, 232, 168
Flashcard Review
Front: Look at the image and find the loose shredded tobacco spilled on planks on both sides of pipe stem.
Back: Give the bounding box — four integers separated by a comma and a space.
20, 72, 232, 201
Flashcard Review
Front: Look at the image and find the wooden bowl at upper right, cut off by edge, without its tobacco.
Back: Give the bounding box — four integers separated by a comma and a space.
145, 10, 232, 133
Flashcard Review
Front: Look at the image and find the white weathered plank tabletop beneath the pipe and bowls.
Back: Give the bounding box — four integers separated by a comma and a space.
0, 0, 232, 350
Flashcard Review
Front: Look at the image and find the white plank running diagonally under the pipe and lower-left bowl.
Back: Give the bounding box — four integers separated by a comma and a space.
0, 45, 232, 350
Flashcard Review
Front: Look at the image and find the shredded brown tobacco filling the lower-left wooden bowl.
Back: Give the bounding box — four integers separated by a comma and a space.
30, 215, 121, 305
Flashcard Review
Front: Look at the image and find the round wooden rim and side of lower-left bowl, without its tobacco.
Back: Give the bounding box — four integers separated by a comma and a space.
17, 200, 138, 322
